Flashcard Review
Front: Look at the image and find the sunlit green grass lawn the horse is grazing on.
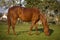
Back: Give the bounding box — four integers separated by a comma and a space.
0, 22, 60, 40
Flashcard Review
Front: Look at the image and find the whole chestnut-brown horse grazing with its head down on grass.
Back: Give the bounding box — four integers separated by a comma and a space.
7, 6, 49, 35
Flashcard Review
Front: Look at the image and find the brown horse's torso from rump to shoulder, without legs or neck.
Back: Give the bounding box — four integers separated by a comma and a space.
8, 6, 40, 21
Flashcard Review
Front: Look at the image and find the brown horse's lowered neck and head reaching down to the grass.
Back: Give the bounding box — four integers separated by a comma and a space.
40, 13, 49, 35
